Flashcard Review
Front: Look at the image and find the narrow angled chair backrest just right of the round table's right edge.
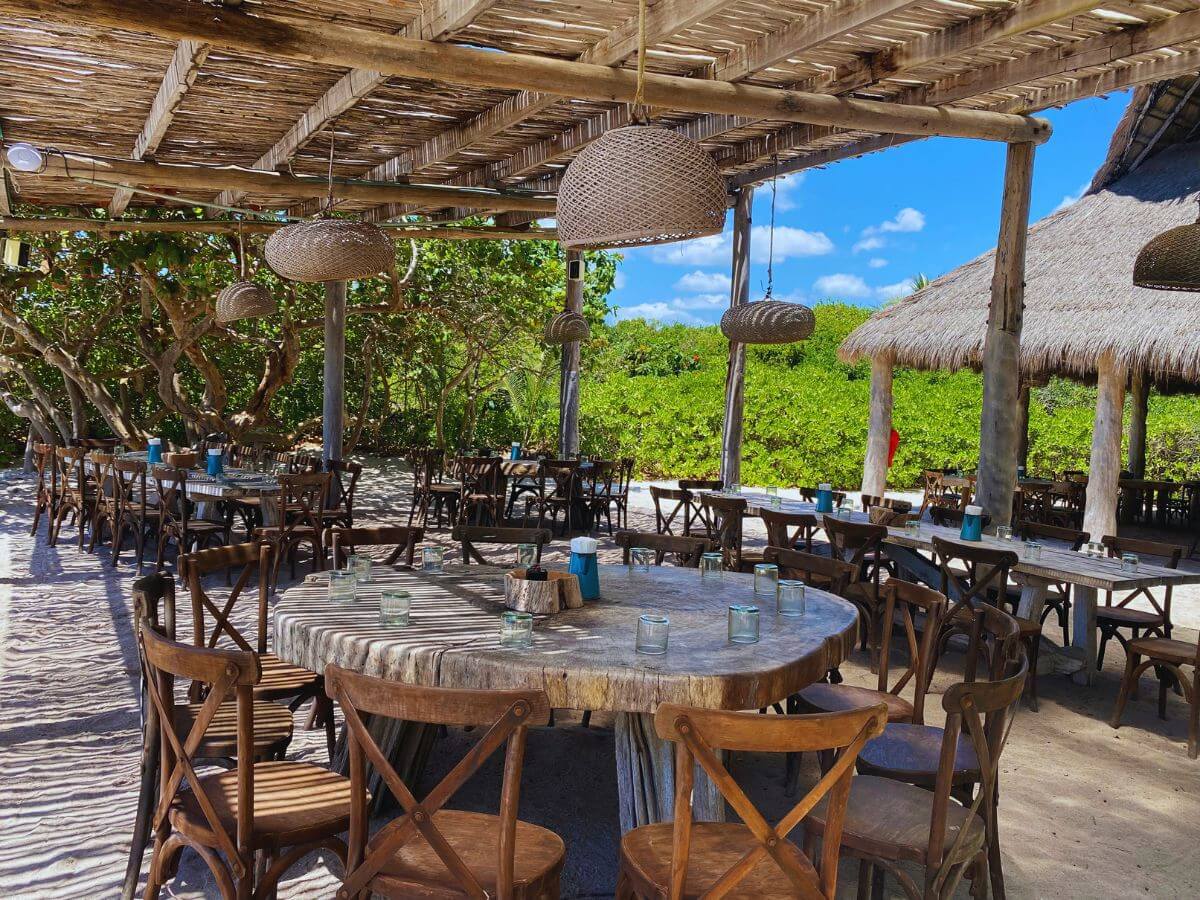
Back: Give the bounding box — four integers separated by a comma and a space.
878, 578, 947, 725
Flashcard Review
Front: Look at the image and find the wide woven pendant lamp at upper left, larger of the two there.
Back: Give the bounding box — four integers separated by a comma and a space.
264, 136, 396, 283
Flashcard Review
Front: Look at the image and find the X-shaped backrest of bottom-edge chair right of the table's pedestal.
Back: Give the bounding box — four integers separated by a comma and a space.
654, 703, 888, 900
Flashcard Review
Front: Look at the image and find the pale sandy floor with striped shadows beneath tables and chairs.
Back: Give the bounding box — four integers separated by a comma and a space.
0, 464, 1200, 898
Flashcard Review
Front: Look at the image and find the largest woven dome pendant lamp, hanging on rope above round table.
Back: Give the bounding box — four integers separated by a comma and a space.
557, 0, 728, 250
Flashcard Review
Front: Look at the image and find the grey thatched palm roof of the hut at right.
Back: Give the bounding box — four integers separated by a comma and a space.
840, 106, 1200, 383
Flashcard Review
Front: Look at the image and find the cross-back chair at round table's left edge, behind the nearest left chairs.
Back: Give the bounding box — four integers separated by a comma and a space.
180, 541, 337, 758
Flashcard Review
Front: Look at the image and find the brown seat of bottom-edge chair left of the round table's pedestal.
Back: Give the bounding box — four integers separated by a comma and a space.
370, 810, 566, 898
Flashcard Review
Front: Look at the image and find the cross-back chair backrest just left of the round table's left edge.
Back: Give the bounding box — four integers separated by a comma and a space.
180, 541, 271, 653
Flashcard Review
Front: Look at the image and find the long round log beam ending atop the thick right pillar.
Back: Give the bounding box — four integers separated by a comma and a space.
16, 0, 1050, 144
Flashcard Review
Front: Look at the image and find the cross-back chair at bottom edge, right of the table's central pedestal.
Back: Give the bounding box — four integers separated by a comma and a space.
617, 703, 887, 900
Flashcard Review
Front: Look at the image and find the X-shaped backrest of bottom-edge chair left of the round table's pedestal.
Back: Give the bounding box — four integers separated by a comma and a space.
325, 665, 550, 898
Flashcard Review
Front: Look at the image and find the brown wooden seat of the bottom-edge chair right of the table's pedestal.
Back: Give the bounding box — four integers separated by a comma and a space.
620, 822, 806, 900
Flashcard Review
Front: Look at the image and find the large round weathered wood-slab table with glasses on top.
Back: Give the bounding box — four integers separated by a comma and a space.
275, 565, 858, 830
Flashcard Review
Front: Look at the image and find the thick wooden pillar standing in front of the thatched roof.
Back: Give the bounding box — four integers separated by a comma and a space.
976, 144, 1033, 524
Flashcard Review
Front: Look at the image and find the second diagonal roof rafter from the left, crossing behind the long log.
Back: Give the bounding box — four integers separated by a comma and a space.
217, 0, 499, 206
